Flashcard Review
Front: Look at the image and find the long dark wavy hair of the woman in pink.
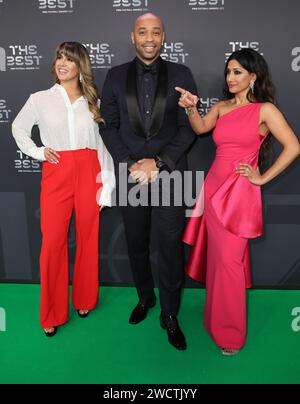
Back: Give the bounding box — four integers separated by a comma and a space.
223, 48, 275, 165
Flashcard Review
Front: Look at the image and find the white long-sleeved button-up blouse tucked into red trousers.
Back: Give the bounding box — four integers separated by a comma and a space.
12, 84, 115, 206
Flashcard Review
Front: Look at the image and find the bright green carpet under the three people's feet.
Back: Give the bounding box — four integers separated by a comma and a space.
0, 284, 300, 384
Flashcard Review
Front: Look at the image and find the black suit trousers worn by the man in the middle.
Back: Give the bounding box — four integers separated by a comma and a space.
121, 174, 185, 316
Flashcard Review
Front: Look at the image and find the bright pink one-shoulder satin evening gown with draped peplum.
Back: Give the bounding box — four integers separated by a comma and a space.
183, 103, 266, 349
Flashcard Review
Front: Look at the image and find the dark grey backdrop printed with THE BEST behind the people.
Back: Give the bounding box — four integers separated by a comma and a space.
0, 0, 300, 288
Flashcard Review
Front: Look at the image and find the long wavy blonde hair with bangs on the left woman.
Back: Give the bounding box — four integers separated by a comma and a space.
52, 42, 103, 123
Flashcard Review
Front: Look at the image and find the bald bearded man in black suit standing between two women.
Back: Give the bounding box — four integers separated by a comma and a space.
100, 13, 197, 350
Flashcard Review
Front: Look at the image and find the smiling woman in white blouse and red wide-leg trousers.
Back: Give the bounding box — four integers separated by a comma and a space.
12, 42, 115, 336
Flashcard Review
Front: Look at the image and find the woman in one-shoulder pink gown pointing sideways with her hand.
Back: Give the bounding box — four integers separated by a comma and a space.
176, 49, 300, 356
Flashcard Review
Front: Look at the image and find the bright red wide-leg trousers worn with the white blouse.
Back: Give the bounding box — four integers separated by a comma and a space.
40, 149, 101, 328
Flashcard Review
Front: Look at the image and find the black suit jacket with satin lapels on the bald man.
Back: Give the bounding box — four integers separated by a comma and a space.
100, 59, 197, 170
